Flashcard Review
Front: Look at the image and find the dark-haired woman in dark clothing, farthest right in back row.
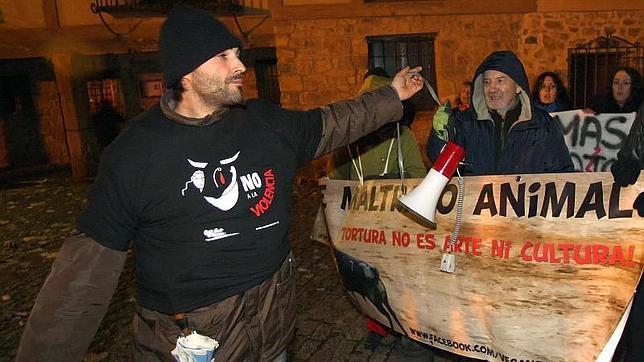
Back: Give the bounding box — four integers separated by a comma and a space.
589, 67, 644, 113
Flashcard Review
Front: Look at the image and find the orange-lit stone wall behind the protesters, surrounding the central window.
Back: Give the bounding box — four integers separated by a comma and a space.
275, 11, 644, 108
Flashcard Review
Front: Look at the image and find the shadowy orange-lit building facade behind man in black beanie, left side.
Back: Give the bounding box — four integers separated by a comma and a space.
0, 0, 274, 176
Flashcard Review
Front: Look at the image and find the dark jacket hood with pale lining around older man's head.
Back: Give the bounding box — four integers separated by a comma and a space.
471, 50, 532, 122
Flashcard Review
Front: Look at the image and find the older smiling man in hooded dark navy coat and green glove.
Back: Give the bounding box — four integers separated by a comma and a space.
427, 51, 574, 175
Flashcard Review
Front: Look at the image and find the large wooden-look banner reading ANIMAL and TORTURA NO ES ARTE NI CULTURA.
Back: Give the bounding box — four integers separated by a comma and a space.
321, 172, 644, 361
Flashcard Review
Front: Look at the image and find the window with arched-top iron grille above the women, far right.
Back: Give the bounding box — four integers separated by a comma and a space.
568, 36, 644, 108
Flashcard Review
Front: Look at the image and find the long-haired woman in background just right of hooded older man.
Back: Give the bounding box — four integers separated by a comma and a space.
532, 72, 570, 113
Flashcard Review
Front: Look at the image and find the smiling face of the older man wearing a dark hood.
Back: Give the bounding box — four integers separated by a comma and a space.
483, 70, 519, 113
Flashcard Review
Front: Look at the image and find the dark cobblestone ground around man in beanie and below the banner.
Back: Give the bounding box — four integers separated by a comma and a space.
0, 174, 464, 361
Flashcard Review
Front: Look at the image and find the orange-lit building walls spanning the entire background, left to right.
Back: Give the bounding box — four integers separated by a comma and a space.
0, 0, 644, 176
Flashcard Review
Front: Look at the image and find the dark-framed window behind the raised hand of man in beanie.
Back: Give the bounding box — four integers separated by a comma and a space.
367, 33, 436, 109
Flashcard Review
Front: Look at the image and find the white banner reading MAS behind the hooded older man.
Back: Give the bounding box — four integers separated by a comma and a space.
550, 109, 635, 172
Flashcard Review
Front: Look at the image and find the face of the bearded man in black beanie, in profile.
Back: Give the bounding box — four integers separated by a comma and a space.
187, 44, 246, 107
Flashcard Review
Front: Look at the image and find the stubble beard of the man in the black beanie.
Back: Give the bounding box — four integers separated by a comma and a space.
193, 72, 245, 110
